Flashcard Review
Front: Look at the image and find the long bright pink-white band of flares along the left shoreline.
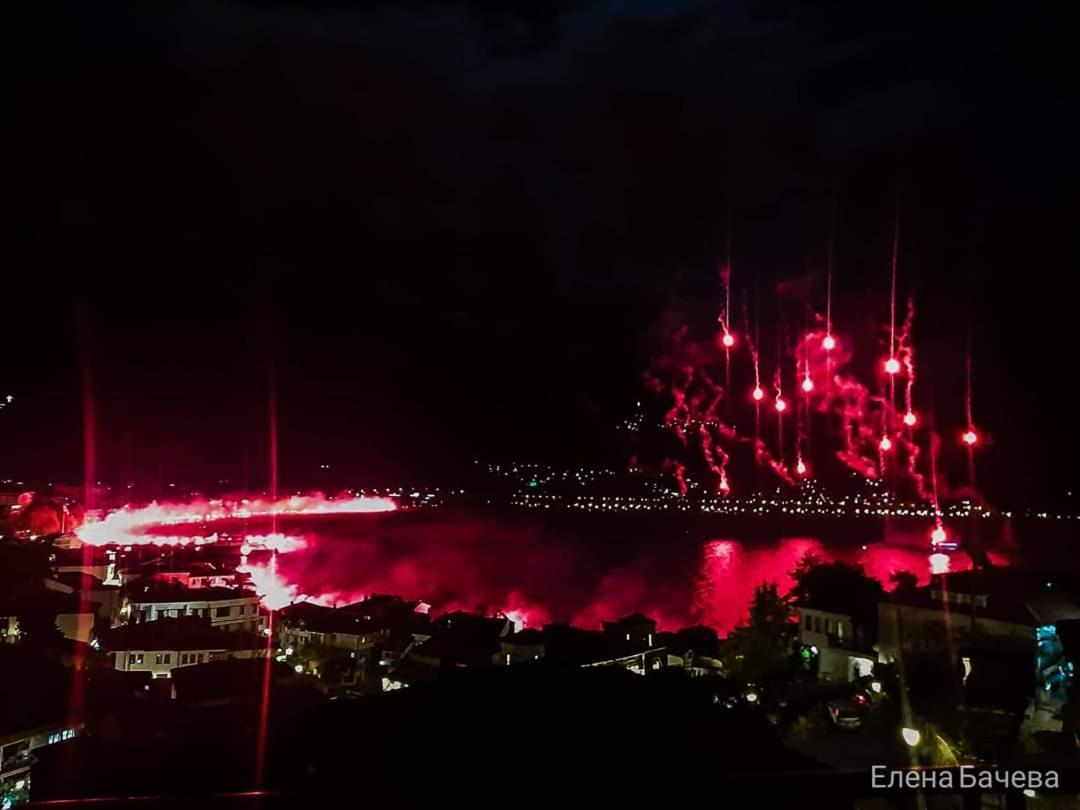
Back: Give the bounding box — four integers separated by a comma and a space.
76, 496, 396, 548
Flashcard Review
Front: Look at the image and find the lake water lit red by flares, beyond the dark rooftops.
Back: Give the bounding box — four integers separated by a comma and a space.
80, 502, 1004, 633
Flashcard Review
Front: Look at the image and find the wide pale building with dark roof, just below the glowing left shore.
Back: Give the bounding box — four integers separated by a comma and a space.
120, 584, 266, 633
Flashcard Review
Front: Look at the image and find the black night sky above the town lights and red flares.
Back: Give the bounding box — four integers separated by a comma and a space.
0, 0, 1080, 505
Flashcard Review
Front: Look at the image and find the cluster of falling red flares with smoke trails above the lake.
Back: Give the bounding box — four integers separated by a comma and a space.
646, 207, 980, 509
